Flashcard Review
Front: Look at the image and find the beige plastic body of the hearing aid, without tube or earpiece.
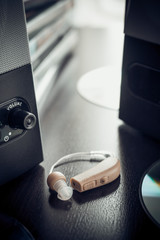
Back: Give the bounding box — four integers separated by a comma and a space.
70, 156, 120, 192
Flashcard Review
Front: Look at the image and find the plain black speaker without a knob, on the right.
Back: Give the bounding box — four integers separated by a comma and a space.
119, 0, 160, 139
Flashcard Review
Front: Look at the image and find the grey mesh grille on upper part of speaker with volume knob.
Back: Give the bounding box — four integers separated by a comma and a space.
0, 0, 30, 74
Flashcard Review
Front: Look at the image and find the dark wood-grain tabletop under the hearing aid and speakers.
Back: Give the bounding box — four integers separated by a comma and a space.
0, 27, 160, 240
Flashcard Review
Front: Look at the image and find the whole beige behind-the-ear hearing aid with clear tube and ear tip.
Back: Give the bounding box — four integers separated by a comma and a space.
47, 151, 120, 201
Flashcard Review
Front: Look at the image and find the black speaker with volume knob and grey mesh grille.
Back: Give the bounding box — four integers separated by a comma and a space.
0, 0, 43, 185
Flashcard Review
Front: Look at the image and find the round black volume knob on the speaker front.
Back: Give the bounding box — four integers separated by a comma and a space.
9, 108, 36, 130
